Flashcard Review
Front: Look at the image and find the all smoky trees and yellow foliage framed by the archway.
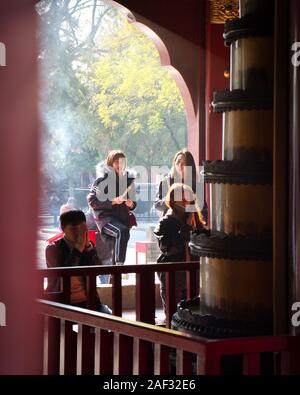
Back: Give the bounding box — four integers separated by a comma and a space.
37, 0, 186, 194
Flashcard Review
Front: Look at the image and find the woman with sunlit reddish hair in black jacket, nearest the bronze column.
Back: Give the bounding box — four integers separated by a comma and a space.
154, 183, 205, 309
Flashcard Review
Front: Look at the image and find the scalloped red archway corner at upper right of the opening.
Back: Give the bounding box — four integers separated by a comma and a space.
105, 0, 206, 164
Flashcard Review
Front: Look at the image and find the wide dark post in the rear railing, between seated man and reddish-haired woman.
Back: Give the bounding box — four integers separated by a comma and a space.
136, 272, 155, 324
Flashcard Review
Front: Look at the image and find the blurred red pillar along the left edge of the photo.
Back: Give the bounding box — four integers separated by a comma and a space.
0, 0, 42, 374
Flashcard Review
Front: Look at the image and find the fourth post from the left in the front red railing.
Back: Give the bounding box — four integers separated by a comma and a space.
94, 328, 114, 375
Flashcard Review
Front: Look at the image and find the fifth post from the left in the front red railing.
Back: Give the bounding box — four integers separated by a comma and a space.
113, 333, 133, 375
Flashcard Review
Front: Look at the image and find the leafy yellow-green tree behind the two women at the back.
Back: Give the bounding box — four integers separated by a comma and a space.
88, 21, 186, 168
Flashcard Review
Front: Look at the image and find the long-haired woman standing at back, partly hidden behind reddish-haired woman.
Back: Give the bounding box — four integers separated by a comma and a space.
154, 148, 207, 222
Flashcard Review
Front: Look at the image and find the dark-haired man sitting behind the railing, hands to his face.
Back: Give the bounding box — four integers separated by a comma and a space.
45, 210, 112, 314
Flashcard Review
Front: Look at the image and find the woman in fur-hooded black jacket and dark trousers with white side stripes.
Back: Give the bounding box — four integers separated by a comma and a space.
87, 150, 136, 265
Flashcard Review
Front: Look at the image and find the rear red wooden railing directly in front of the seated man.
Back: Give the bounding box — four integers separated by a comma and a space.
39, 262, 199, 328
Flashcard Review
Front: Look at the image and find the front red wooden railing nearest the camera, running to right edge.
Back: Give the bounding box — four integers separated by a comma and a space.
38, 300, 300, 375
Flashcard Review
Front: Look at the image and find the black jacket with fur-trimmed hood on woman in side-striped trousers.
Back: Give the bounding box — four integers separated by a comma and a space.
87, 164, 136, 227
